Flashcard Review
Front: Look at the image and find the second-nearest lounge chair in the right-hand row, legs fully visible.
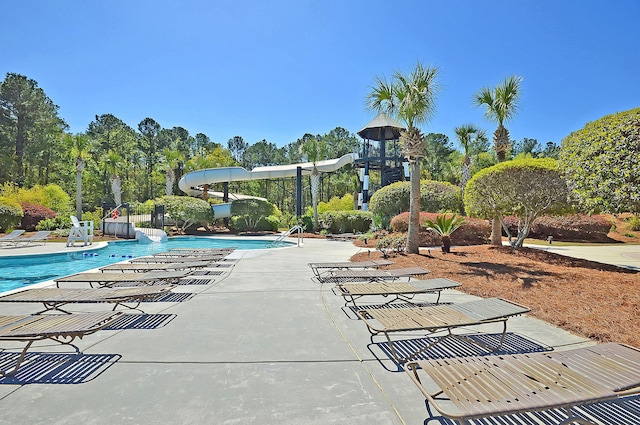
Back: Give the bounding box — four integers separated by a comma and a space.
357, 298, 529, 363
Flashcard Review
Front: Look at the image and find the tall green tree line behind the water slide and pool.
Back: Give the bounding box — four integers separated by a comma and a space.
0, 73, 558, 219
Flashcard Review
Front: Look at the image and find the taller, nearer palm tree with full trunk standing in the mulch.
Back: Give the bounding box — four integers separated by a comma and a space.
366, 62, 440, 254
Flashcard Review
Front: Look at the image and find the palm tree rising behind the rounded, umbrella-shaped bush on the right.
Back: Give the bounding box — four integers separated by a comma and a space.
473, 75, 522, 246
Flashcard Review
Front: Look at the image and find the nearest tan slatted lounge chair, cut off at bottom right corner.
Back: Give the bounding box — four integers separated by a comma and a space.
405, 343, 640, 424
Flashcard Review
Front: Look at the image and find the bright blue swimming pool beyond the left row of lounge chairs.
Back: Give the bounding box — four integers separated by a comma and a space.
0, 236, 292, 292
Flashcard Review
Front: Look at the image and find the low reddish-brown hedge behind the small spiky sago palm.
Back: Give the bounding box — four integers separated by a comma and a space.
391, 212, 491, 246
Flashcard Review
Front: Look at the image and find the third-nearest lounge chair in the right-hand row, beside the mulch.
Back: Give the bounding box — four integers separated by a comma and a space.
335, 278, 460, 307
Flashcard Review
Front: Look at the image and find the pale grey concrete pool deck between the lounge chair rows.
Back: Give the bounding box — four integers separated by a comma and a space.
0, 239, 640, 425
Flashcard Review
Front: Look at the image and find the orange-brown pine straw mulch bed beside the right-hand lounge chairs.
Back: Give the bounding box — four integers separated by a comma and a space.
351, 244, 640, 347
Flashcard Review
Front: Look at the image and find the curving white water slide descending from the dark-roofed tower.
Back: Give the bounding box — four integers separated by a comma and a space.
178, 153, 358, 218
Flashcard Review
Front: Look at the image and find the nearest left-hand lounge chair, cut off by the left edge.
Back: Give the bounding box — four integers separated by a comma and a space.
0, 311, 122, 376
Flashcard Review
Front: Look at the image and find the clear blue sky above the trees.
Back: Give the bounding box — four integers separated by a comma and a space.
5, 0, 640, 151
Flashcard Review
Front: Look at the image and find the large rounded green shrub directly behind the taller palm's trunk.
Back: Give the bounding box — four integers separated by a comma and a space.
369, 180, 462, 228
